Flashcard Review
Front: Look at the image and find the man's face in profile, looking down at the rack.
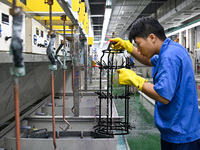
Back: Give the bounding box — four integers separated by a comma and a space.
134, 36, 155, 58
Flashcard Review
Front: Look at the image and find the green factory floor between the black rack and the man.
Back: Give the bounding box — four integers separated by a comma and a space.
115, 89, 161, 150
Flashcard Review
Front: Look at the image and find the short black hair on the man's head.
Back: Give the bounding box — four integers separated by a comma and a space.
129, 17, 166, 43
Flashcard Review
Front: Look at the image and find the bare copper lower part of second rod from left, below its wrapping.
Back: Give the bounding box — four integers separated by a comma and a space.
51, 71, 56, 150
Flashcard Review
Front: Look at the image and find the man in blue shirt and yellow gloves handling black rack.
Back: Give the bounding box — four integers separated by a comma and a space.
111, 17, 200, 150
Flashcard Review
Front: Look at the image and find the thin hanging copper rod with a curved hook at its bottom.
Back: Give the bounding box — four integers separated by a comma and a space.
60, 15, 70, 131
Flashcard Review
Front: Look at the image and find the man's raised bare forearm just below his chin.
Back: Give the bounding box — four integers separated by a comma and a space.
131, 47, 153, 66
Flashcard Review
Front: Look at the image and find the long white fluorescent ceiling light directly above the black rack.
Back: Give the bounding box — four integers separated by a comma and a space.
100, 8, 112, 48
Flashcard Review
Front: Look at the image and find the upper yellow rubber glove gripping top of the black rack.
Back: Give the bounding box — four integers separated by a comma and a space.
110, 37, 133, 54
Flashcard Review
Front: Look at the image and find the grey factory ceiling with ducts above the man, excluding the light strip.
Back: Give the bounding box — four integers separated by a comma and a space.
85, 0, 200, 43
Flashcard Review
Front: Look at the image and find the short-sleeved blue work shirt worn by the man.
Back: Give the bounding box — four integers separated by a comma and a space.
151, 38, 200, 143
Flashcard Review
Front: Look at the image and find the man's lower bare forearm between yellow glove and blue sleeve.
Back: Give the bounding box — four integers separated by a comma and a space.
142, 82, 169, 104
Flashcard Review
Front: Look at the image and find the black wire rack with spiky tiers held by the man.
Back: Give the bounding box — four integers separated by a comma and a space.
94, 43, 132, 137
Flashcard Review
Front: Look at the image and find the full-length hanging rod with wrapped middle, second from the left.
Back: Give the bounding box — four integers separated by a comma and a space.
45, 0, 57, 150
